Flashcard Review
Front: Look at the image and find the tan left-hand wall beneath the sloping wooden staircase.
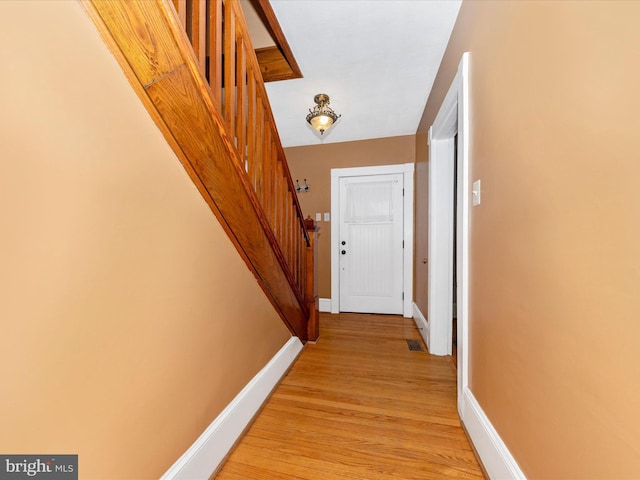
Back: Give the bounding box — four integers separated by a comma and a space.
0, 1, 290, 479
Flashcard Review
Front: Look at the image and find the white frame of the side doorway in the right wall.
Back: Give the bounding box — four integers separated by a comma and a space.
426, 53, 470, 412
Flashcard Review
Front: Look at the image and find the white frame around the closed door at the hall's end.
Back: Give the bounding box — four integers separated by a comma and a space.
331, 163, 414, 318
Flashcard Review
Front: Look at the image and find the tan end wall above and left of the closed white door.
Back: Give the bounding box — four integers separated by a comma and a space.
285, 135, 415, 298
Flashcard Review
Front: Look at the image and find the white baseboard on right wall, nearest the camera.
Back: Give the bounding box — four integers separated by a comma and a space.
461, 388, 527, 480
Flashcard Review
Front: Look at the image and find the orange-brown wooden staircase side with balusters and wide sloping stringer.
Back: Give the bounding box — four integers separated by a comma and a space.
83, 0, 310, 341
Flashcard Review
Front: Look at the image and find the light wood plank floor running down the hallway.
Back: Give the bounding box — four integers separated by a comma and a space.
216, 314, 483, 480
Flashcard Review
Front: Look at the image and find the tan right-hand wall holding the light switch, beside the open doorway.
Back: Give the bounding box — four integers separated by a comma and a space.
417, 1, 640, 479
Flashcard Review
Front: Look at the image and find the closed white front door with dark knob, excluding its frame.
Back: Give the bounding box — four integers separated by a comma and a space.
333, 173, 404, 314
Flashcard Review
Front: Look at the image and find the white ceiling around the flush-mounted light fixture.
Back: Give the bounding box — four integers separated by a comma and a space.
266, 0, 461, 147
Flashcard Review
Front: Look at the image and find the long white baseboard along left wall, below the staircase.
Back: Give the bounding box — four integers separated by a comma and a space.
161, 337, 303, 480
